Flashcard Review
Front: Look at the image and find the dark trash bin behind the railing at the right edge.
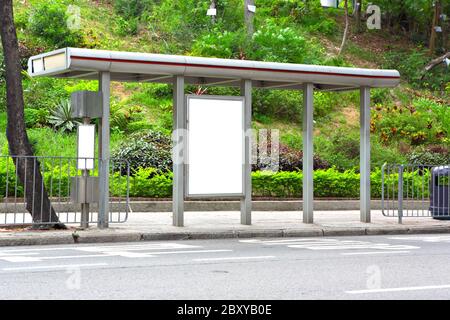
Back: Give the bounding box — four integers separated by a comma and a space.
430, 166, 450, 220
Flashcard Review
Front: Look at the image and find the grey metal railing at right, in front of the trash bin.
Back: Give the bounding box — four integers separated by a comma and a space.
381, 164, 450, 223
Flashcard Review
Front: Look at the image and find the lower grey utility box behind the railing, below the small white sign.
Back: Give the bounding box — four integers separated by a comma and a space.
70, 176, 99, 203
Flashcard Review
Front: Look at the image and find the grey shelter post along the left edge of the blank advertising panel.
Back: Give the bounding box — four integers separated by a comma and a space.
172, 76, 186, 227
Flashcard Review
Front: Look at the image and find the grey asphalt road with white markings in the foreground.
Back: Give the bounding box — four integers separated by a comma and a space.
0, 235, 450, 300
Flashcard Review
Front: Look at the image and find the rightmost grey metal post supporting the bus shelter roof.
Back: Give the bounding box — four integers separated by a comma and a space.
359, 87, 370, 223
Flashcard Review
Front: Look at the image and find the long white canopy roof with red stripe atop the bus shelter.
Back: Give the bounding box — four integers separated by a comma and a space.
28, 48, 400, 91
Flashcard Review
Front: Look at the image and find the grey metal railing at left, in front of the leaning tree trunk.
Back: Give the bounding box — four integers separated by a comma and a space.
0, 156, 130, 226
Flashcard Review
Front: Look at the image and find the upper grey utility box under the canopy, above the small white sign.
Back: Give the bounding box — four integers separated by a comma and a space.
70, 91, 103, 119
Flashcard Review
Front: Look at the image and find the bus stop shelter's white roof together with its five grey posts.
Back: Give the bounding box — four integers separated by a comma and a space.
28, 48, 400, 228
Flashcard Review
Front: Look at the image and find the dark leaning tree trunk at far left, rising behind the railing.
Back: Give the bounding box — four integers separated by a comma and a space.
0, 0, 65, 228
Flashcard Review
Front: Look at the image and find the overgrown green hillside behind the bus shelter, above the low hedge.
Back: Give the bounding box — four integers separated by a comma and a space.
0, 0, 450, 178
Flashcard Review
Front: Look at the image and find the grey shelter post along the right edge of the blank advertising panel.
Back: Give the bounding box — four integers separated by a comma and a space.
241, 80, 252, 225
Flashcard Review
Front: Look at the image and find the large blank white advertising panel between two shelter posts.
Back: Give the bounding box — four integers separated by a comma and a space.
186, 96, 244, 196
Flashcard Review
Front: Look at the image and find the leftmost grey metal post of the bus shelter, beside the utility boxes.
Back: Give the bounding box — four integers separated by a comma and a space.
98, 72, 111, 229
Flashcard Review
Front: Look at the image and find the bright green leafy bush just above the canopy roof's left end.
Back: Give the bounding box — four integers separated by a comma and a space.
29, 1, 83, 48
